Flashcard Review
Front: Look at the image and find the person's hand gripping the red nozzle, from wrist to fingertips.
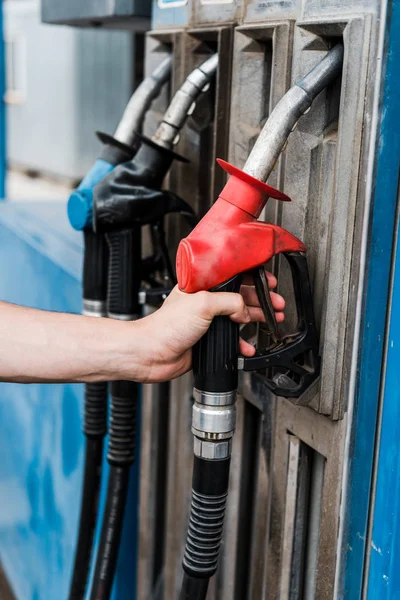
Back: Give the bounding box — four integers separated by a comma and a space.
135, 273, 285, 382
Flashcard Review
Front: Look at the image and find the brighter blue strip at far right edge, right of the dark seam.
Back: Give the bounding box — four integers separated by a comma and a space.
366, 2, 400, 584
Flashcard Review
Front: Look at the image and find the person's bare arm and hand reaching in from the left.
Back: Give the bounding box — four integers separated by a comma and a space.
0, 278, 285, 383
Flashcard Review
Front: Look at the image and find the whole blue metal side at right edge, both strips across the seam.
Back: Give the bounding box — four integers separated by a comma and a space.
340, 1, 400, 600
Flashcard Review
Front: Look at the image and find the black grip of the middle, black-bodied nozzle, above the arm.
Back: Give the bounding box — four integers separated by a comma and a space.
106, 226, 141, 318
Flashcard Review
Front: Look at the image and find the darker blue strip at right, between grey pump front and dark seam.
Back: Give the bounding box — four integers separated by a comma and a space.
340, 2, 400, 600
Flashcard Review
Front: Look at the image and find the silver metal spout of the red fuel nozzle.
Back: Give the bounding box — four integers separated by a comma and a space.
243, 44, 344, 181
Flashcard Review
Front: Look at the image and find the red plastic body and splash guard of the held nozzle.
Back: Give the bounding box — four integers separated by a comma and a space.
176, 159, 306, 293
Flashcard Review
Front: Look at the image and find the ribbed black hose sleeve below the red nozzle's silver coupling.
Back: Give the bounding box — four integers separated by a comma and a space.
183, 456, 230, 579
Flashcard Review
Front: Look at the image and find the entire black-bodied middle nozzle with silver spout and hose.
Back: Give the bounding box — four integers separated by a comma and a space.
69, 55, 218, 600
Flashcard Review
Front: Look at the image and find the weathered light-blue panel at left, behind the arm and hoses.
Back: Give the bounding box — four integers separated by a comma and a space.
0, 202, 138, 600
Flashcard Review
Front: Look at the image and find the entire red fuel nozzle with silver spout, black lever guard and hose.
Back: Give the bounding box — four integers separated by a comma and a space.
177, 44, 343, 600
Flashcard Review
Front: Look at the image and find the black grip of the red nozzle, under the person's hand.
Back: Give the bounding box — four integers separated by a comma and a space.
193, 276, 242, 392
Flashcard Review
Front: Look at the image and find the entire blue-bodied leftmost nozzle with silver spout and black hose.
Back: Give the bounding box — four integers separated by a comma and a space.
68, 57, 172, 600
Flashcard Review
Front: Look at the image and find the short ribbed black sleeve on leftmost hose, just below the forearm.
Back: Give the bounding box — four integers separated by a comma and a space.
83, 382, 108, 437
